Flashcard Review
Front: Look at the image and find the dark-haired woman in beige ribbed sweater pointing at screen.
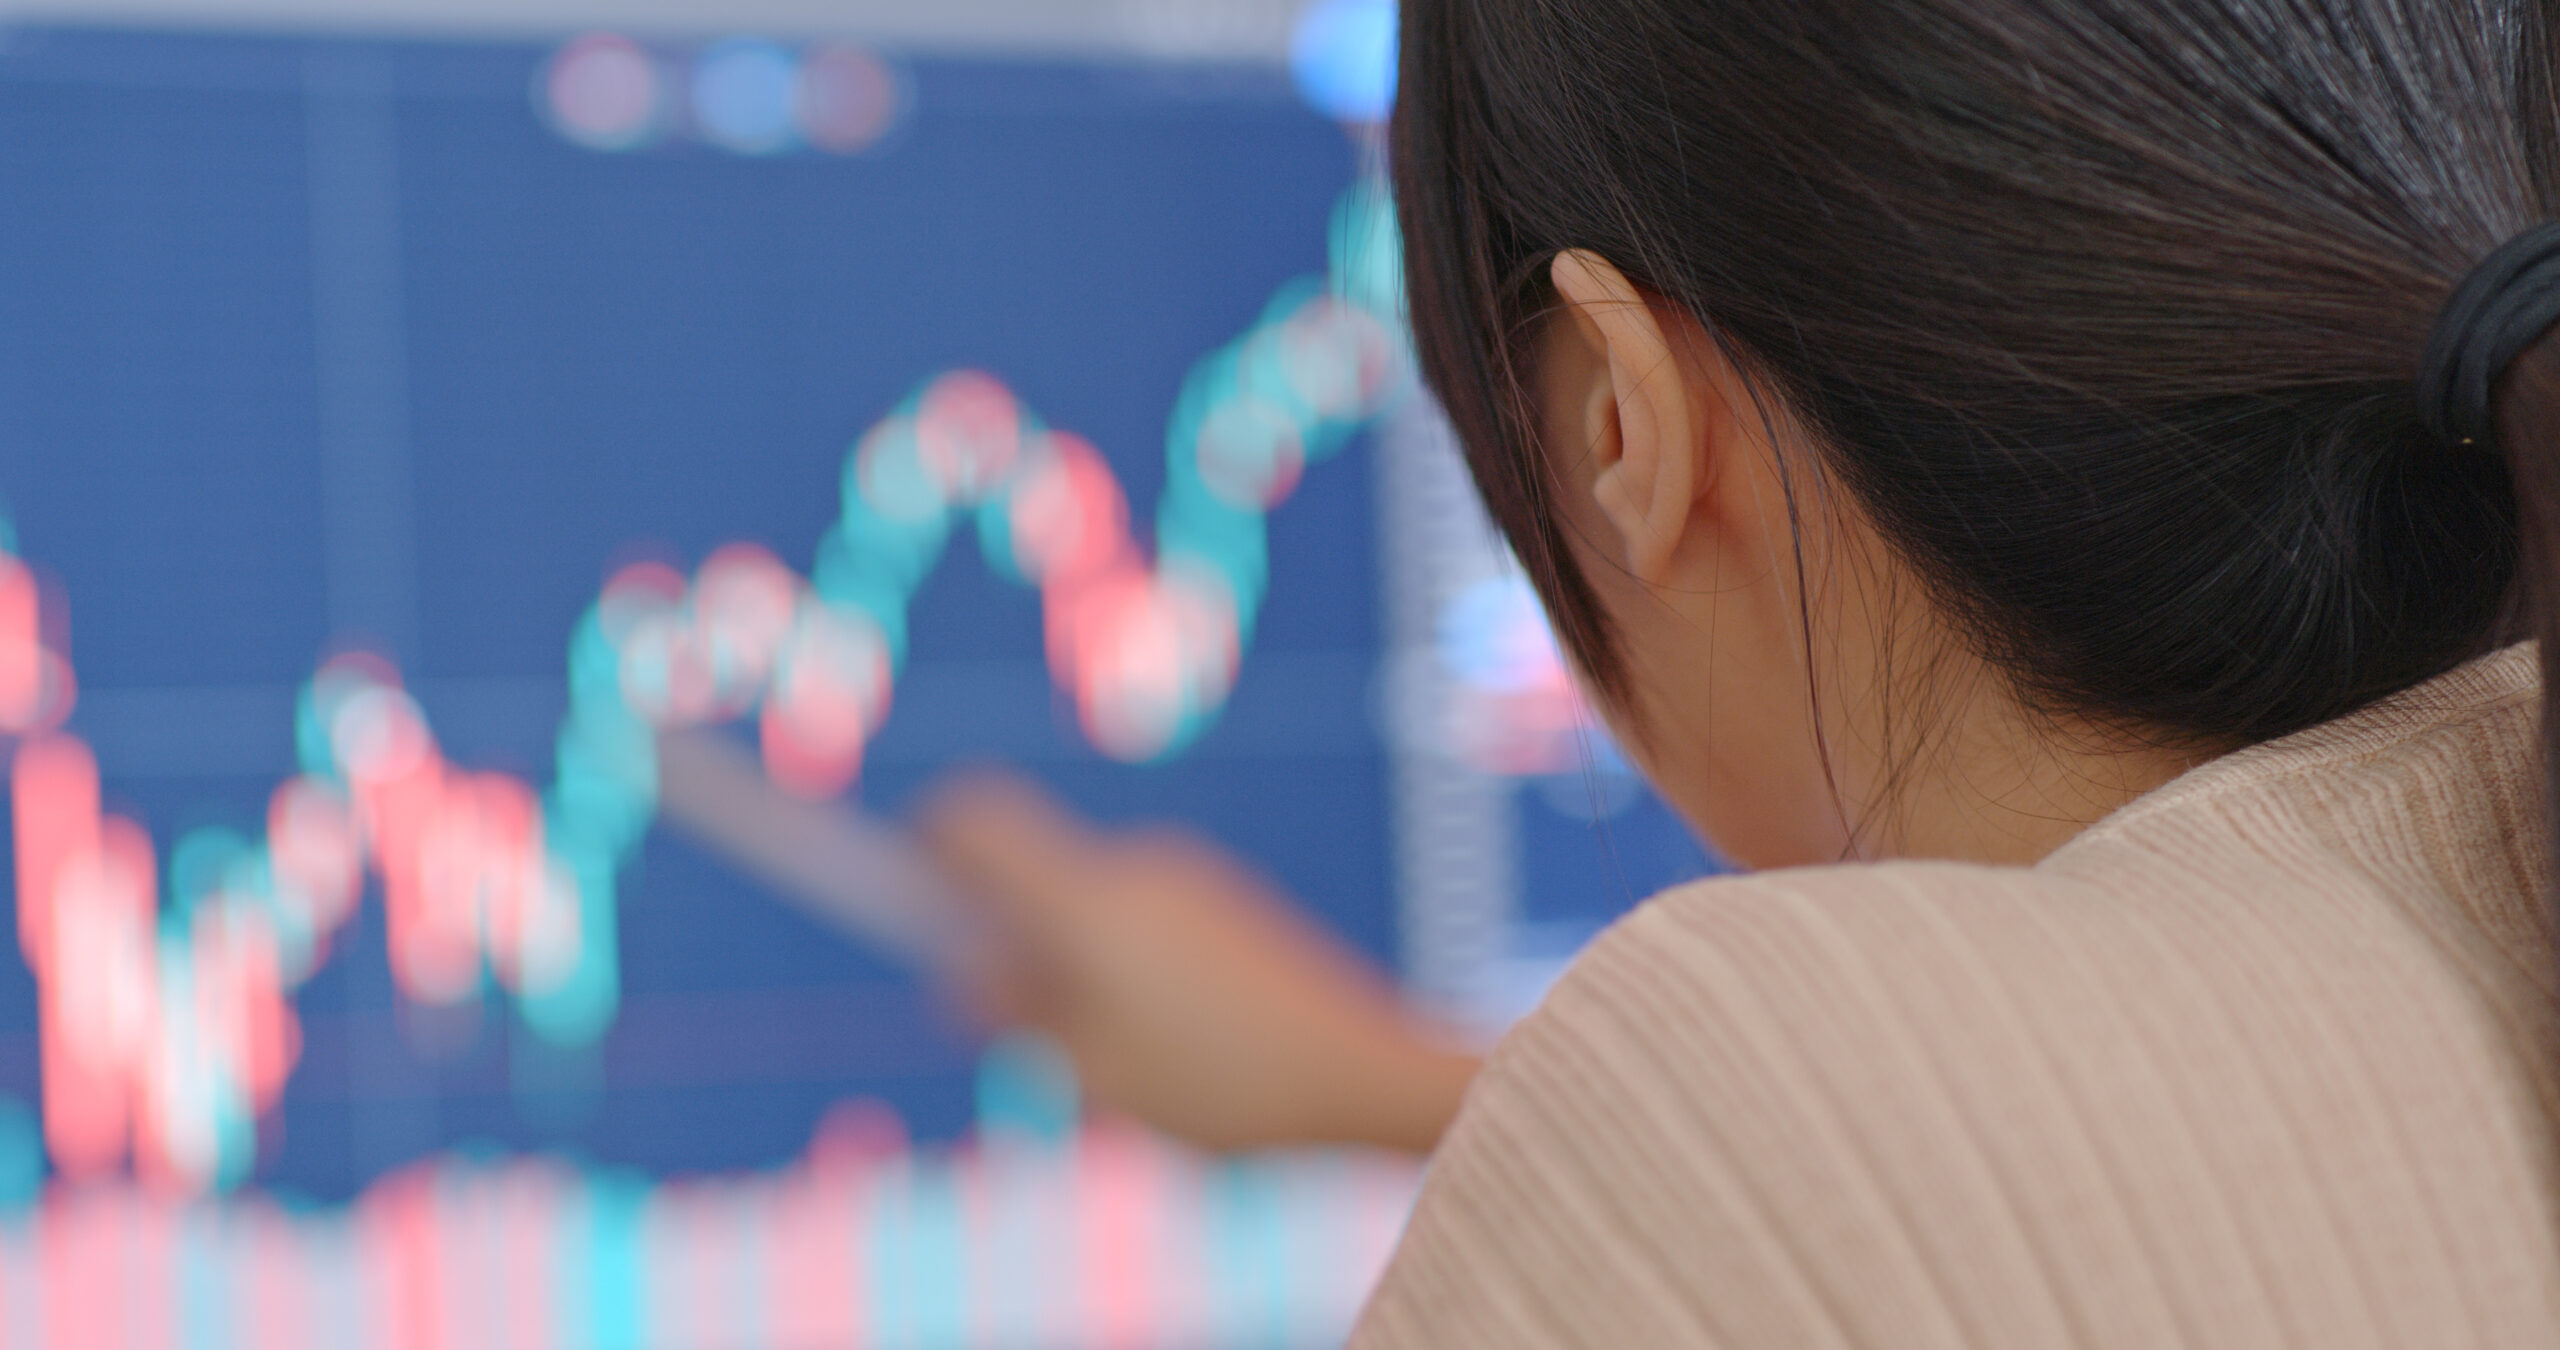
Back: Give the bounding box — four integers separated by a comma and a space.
937, 0, 2560, 1350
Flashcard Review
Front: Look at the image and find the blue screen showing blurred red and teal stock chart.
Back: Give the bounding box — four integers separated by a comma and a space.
0, 28, 1710, 1347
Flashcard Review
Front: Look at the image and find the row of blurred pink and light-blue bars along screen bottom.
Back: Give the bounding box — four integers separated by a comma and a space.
0, 1107, 1416, 1350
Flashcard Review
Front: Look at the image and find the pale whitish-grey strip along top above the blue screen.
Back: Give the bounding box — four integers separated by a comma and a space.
0, 0, 1300, 64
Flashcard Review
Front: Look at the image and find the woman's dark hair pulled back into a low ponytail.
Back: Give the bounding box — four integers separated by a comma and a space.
1393, 0, 2560, 845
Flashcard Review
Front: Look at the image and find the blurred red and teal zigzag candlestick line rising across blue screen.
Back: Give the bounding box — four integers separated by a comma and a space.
0, 184, 1405, 1194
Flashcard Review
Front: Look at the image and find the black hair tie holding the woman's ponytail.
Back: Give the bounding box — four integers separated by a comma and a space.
2417, 220, 2560, 446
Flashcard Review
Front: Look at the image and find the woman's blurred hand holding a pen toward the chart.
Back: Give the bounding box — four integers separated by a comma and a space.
922, 776, 1477, 1153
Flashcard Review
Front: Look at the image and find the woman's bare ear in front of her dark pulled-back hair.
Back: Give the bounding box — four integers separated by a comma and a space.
1551, 248, 1708, 584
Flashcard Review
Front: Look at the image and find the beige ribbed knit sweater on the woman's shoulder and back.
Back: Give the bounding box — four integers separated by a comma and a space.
1352, 648, 2560, 1350
